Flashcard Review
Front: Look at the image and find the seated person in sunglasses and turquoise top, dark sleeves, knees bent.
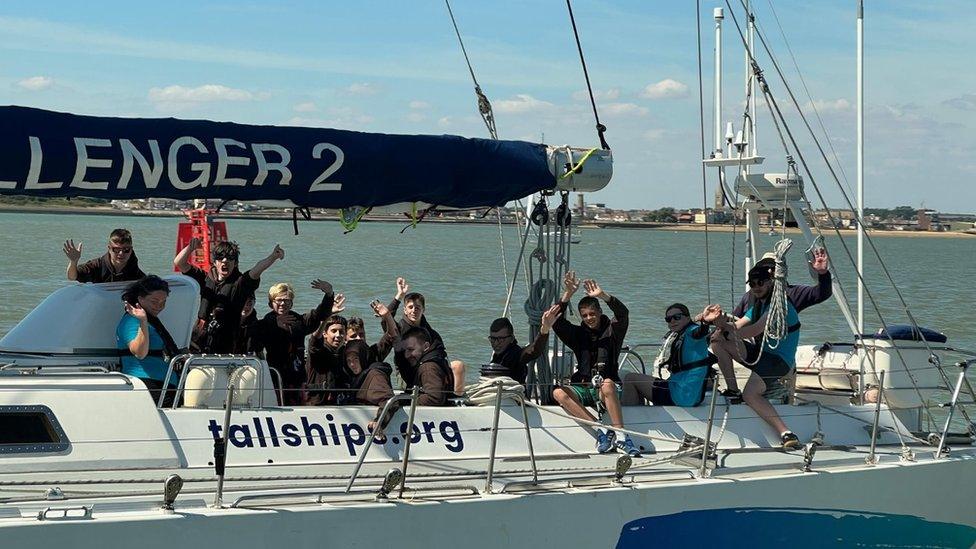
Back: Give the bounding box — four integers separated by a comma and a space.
622, 303, 730, 407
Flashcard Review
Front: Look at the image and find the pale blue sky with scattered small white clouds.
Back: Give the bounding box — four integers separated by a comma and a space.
0, 0, 976, 213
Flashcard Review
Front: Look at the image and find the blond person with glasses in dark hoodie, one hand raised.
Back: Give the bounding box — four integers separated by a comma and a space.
243, 280, 336, 406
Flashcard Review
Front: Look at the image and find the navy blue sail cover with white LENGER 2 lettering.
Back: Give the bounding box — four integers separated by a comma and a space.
0, 106, 556, 208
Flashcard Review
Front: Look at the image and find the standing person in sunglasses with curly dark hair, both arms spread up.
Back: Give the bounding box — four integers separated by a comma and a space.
173, 238, 285, 354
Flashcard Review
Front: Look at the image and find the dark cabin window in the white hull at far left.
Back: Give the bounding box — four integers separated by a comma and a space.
0, 405, 68, 454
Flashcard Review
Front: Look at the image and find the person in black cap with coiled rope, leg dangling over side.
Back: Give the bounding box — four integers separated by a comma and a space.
710, 248, 833, 448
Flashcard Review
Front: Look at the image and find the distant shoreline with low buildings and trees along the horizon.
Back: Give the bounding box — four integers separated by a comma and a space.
0, 204, 976, 238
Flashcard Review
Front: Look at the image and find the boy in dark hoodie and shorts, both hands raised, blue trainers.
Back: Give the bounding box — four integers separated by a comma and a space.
552, 271, 640, 456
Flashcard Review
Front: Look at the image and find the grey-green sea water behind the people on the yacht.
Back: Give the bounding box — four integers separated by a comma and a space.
0, 213, 976, 386
